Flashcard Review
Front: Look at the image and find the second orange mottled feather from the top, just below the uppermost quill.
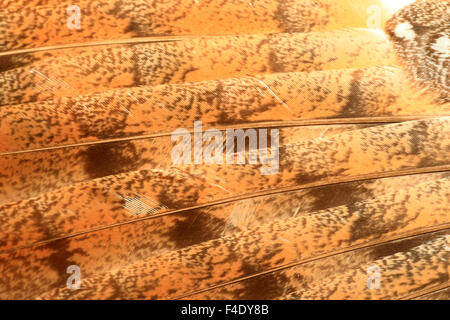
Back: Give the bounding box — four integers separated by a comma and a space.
0, 29, 394, 105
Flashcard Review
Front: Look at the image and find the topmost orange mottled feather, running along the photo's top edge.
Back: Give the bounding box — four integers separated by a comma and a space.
0, 0, 398, 51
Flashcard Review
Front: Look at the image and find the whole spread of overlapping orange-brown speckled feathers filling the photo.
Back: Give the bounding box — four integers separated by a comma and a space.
0, 0, 450, 300
